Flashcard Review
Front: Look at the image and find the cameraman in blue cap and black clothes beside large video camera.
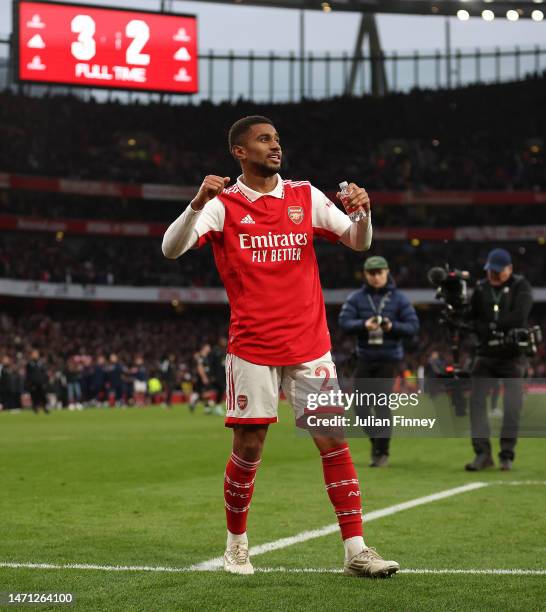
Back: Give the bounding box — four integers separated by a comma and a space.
465, 249, 533, 472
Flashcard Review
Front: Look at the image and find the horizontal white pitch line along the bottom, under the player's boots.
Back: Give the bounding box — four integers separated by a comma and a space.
0, 561, 546, 576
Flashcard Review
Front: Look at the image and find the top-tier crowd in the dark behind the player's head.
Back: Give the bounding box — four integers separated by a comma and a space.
0, 74, 546, 190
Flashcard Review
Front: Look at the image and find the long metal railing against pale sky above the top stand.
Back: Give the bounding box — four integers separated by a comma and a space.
0, 40, 546, 103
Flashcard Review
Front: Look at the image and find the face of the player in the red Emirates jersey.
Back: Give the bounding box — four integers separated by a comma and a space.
234, 123, 282, 177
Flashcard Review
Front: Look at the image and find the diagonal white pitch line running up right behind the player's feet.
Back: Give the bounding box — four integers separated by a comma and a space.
192, 482, 489, 570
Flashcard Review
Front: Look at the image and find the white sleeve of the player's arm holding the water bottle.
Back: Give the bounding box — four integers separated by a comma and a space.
311, 185, 372, 251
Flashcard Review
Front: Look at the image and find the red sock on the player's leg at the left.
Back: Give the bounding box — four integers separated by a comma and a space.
224, 453, 260, 534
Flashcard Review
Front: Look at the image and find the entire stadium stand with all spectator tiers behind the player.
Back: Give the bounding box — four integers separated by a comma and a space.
0, 75, 546, 407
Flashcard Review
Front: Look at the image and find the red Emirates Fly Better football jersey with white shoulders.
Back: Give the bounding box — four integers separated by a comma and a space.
195, 176, 351, 366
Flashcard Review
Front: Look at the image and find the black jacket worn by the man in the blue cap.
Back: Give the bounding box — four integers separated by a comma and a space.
469, 274, 533, 357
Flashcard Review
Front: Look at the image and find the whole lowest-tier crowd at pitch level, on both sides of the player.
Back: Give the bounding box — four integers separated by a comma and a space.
0, 305, 546, 409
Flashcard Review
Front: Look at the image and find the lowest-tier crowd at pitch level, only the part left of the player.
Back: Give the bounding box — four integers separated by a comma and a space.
0, 308, 225, 409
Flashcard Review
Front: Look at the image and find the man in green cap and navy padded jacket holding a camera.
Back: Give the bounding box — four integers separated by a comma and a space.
339, 256, 419, 467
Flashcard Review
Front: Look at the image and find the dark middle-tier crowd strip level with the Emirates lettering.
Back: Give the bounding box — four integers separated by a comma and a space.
0, 232, 546, 289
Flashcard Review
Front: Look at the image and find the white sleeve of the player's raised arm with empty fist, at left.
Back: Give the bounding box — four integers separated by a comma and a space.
161, 198, 226, 259
